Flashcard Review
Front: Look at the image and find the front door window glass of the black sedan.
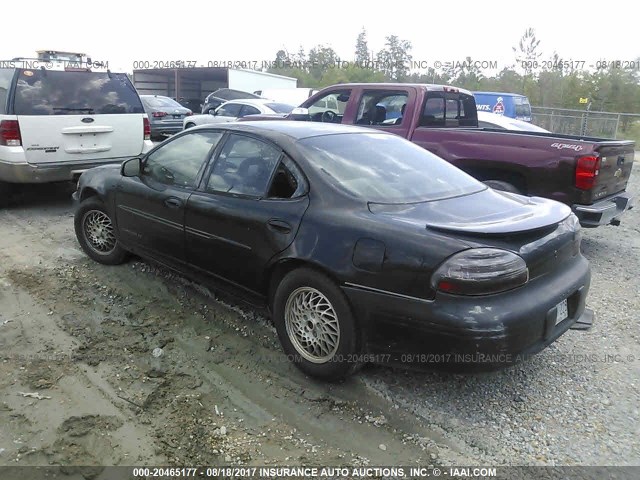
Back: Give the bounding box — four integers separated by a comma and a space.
142, 131, 222, 188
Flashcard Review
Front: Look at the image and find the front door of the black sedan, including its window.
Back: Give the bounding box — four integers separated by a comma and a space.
115, 130, 223, 262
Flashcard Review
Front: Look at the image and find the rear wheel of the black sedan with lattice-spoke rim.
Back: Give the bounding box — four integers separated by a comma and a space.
272, 268, 361, 380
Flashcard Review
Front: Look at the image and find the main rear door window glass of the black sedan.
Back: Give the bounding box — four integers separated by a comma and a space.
206, 134, 282, 197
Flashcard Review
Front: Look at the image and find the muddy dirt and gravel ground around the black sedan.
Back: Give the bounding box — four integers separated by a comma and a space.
0, 174, 640, 472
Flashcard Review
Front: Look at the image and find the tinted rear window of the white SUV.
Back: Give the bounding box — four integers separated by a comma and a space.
13, 70, 144, 115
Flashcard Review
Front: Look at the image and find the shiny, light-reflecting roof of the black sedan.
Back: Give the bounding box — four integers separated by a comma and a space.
190, 120, 390, 141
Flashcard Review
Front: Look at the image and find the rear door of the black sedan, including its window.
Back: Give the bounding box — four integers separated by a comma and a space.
185, 133, 309, 292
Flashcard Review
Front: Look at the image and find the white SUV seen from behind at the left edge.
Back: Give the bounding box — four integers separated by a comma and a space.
0, 60, 153, 205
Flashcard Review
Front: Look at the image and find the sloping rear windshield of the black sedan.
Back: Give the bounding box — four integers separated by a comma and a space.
298, 133, 486, 203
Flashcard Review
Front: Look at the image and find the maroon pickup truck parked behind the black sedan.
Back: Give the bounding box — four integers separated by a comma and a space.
244, 83, 635, 227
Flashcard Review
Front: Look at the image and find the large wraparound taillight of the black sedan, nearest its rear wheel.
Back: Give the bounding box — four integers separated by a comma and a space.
431, 248, 529, 295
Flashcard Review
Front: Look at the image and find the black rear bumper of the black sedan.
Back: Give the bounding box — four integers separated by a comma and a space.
343, 255, 593, 369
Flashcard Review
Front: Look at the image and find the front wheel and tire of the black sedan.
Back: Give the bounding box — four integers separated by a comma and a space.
74, 197, 128, 265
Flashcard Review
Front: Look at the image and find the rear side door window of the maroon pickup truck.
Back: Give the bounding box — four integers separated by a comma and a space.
355, 91, 409, 127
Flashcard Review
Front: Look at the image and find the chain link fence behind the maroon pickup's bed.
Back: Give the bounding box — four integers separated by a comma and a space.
531, 107, 640, 144
